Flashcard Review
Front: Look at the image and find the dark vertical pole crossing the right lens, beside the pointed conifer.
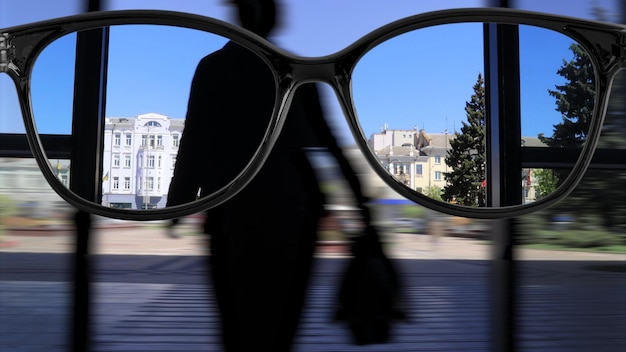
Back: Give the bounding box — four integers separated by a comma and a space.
485, 23, 522, 352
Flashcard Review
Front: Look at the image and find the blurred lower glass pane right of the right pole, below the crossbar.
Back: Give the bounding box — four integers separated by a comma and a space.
517, 169, 626, 351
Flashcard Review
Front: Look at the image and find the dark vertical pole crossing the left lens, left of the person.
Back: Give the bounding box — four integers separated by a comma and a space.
70, 0, 108, 352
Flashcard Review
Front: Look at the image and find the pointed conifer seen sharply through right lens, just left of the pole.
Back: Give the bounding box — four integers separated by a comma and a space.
443, 73, 485, 206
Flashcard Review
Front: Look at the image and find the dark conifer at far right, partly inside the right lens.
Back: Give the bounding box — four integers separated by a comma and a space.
540, 44, 626, 229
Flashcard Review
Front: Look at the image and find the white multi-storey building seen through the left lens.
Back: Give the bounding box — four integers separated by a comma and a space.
102, 113, 185, 209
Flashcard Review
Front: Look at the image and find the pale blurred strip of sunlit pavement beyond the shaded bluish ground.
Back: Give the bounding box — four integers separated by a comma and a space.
0, 222, 626, 261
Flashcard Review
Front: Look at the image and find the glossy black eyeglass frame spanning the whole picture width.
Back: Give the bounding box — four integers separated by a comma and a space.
0, 8, 626, 220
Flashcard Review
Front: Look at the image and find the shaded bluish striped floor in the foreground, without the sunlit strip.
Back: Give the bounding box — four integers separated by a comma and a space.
0, 256, 626, 352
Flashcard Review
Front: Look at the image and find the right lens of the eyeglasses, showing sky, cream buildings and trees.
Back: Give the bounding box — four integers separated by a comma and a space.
352, 22, 595, 212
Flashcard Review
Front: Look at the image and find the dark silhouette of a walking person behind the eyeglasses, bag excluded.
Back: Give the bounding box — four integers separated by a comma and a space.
168, 0, 376, 352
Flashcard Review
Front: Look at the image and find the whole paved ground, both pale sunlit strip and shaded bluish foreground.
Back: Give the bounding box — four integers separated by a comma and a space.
0, 224, 626, 352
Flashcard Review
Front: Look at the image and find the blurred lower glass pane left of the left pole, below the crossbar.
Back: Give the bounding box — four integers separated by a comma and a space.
0, 158, 74, 352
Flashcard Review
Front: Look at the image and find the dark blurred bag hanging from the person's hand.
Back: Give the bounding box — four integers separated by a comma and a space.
335, 225, 406, 345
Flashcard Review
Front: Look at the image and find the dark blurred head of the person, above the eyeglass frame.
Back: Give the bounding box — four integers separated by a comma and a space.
231, 0, 278, 38
